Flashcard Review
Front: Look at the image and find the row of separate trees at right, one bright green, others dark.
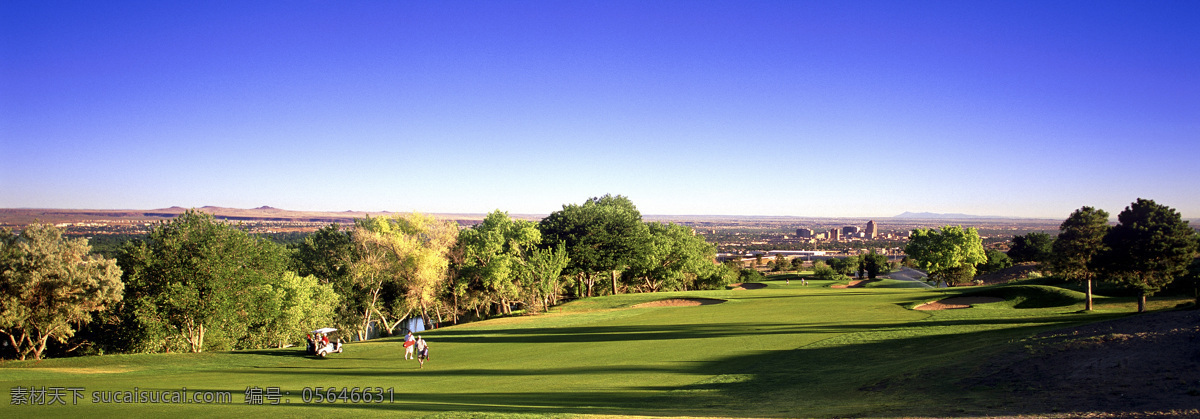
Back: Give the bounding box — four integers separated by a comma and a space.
905, 198, 1200, 312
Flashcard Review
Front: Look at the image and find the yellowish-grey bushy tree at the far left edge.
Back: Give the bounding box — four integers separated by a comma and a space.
0, 223, 125, 359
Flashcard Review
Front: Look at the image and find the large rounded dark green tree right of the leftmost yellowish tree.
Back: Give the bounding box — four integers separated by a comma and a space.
118, 210, 288, 352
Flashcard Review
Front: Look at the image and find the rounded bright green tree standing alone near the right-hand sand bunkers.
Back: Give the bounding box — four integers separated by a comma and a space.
904, 226, 988, 285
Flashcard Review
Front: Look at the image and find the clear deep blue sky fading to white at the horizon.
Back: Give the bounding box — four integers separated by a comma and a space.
0, 0, 1200, 219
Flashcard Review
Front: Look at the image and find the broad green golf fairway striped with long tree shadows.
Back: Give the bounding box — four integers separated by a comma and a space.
0, 276, 1180, 417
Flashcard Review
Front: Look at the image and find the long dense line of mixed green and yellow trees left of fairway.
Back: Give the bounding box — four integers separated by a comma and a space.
0, 194, 745, 359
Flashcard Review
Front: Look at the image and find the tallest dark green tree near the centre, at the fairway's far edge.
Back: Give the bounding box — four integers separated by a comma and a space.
538, 194, 649, 297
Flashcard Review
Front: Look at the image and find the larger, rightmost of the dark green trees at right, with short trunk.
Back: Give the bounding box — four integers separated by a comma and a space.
1098, 198, 1196, 312
